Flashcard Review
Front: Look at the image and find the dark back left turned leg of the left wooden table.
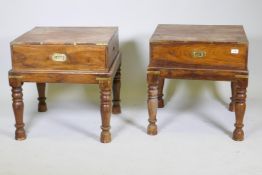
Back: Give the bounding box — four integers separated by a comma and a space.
36, 83, 47, 112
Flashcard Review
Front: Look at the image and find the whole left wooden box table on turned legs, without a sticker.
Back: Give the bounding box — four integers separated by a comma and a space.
9, 27, 121, 143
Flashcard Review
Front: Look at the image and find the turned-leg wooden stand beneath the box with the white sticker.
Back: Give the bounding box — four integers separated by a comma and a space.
147, 67, 248, 141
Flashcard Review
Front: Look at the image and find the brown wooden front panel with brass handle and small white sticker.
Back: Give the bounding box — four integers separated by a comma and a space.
150, 44, 247, 70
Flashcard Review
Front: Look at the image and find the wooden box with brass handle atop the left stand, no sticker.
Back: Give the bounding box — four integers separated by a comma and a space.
11, 27, 119, 72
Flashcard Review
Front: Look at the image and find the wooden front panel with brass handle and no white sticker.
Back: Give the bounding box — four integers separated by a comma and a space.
12, 45, 107, 71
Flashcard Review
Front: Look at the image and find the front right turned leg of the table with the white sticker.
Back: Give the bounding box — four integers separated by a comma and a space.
233, 79, 248, 141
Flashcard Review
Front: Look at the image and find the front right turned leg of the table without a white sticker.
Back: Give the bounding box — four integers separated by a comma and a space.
99, 78, 112, 143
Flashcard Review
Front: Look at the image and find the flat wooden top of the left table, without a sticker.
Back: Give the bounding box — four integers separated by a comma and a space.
11, 27, 118, 45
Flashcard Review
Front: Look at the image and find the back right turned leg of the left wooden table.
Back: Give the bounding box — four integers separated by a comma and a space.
112, 66, 121, 114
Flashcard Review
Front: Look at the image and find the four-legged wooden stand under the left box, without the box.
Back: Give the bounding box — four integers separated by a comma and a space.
9, 54, 121, 143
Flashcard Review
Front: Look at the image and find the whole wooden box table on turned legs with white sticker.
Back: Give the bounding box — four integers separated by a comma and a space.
147, 24, 248, 141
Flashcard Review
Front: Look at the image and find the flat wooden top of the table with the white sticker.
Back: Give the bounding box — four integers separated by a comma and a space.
150, 24, 248, 44
